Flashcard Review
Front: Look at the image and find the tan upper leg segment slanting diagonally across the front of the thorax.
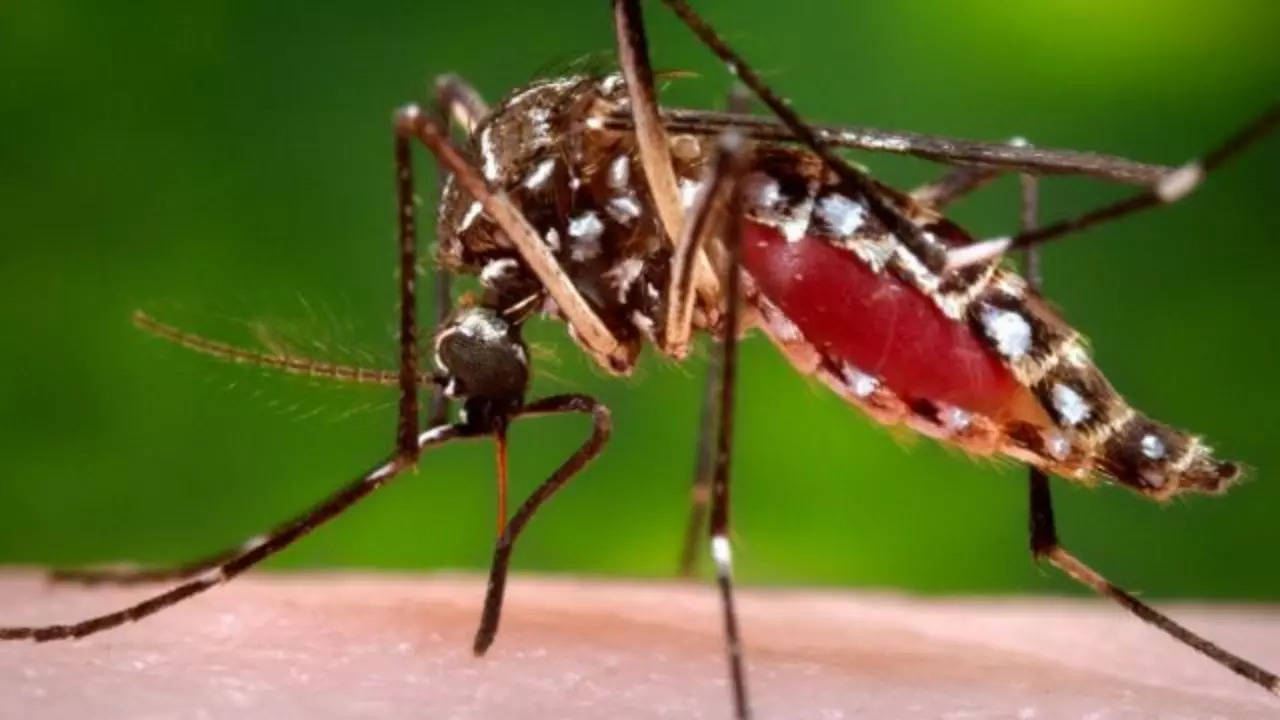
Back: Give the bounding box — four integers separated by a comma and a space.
396, 105, 631, 369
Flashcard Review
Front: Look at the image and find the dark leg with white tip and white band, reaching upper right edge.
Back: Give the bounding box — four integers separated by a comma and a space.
947, 104, 1280, 268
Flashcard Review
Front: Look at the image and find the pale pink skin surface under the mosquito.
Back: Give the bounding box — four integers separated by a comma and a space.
0, 571, 1280, 720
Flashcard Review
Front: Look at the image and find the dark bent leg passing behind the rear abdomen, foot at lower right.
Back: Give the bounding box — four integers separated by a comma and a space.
1021, 176, 1280, 694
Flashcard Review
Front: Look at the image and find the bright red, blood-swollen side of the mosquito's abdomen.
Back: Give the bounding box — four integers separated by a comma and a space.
742, 220, 1021, 418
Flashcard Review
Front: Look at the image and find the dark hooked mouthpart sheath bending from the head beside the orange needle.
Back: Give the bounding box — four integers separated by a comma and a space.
472, 395, 613, 655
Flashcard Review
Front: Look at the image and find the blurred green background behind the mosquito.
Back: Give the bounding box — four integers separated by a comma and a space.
0, 0, 1280, 598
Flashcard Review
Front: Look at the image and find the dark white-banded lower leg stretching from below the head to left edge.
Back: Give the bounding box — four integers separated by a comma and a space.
0, 425, 472, 642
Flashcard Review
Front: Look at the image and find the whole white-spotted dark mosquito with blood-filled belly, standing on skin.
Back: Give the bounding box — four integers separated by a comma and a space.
0, 0, 1280, 717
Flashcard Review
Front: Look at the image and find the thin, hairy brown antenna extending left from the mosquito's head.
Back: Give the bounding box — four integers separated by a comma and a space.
133, 310, 434, 387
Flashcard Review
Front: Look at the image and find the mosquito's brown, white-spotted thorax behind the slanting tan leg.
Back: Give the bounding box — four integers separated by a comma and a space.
438, 76, 704, 374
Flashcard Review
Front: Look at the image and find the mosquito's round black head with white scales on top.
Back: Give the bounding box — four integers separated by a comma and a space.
435, 307, 529, 401
